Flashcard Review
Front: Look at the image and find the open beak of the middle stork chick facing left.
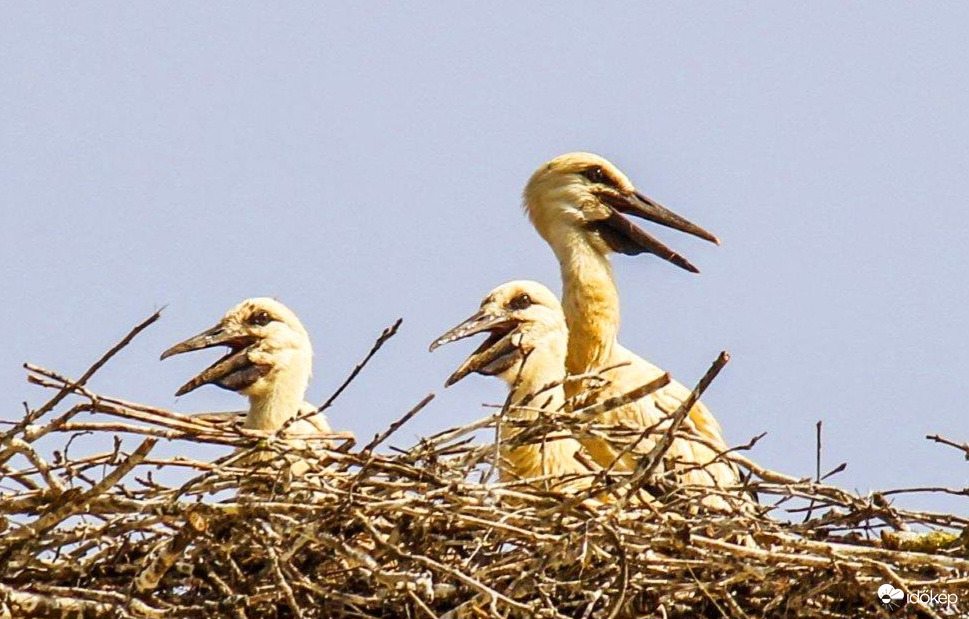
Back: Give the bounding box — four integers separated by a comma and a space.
430, 310, 523, 387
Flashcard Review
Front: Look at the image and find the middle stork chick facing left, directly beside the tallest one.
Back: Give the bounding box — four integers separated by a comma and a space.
430, 280, 599, 491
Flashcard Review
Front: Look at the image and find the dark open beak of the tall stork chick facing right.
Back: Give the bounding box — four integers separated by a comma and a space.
593, 191, 720, 273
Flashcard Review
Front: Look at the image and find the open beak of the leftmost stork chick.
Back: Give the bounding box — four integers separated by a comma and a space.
161, 325, 262, 396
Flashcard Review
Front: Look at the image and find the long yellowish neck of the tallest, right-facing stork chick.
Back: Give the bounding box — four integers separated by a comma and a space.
553, 233, 619, 374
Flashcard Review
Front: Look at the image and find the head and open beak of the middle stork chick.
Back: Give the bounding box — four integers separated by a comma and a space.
430, 280, 568, 387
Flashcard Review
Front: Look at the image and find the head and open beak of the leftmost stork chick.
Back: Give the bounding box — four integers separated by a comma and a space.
161, 298, 313, 398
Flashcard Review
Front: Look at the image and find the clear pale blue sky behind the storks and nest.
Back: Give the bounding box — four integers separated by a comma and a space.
0, 2, 969, 511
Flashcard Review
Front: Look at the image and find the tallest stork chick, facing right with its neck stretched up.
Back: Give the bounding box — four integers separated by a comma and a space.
524, 153, 739, 502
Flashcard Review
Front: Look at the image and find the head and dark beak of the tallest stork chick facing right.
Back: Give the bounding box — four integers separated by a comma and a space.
524, 153, 720, 273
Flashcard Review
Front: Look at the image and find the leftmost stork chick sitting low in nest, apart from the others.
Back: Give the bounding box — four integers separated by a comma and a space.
161, 298, 331, 436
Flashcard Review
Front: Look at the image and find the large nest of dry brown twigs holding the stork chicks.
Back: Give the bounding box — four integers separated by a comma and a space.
0, 315, 969, 619
